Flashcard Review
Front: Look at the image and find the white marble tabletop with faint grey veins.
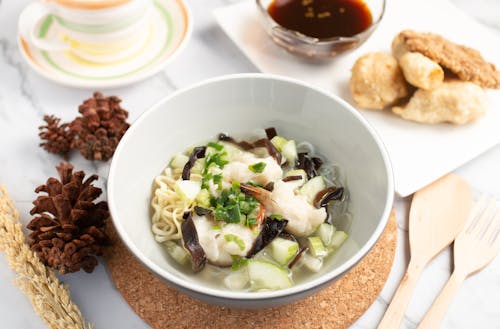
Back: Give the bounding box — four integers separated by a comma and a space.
0, 0, 500, 329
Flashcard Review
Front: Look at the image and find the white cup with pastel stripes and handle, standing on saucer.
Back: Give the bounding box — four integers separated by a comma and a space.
19, 0, 152, 63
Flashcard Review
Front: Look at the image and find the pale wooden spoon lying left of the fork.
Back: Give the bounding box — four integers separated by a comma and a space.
378, 174, 472, 329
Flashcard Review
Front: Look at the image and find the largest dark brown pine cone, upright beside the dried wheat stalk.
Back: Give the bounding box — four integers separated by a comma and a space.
27, 163, 109, 274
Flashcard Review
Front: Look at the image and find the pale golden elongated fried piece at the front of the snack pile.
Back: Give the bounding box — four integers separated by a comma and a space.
392, 80, 487, 125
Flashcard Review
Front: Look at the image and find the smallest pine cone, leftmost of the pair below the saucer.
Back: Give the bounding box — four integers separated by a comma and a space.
38, 115, 73, 156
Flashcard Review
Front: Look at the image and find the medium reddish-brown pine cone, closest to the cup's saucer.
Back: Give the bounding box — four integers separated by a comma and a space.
70, 92, 130, 160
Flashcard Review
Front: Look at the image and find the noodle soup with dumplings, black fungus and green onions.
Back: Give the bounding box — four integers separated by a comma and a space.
151, 128, 350, 291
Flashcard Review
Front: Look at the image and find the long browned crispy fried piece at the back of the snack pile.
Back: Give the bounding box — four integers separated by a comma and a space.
392, 30, 500, 89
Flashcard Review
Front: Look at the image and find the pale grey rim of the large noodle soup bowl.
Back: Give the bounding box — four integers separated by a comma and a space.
107, 73, 394, 301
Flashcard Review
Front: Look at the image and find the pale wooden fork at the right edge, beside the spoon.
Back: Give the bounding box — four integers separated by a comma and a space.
417, 195, 500, 329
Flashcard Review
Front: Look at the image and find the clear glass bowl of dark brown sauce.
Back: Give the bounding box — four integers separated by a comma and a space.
256, 0, 385, 59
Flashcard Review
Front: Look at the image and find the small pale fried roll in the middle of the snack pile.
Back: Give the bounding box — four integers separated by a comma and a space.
399, 52, 444, 90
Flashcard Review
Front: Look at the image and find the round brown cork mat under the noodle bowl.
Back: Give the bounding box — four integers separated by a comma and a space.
105, 211, 397, 329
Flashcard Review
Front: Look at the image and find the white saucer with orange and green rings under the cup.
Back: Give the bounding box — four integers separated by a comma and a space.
18, 0, 191, 88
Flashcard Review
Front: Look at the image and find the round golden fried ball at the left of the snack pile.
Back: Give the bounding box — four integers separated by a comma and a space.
349, 52, 409, 110
